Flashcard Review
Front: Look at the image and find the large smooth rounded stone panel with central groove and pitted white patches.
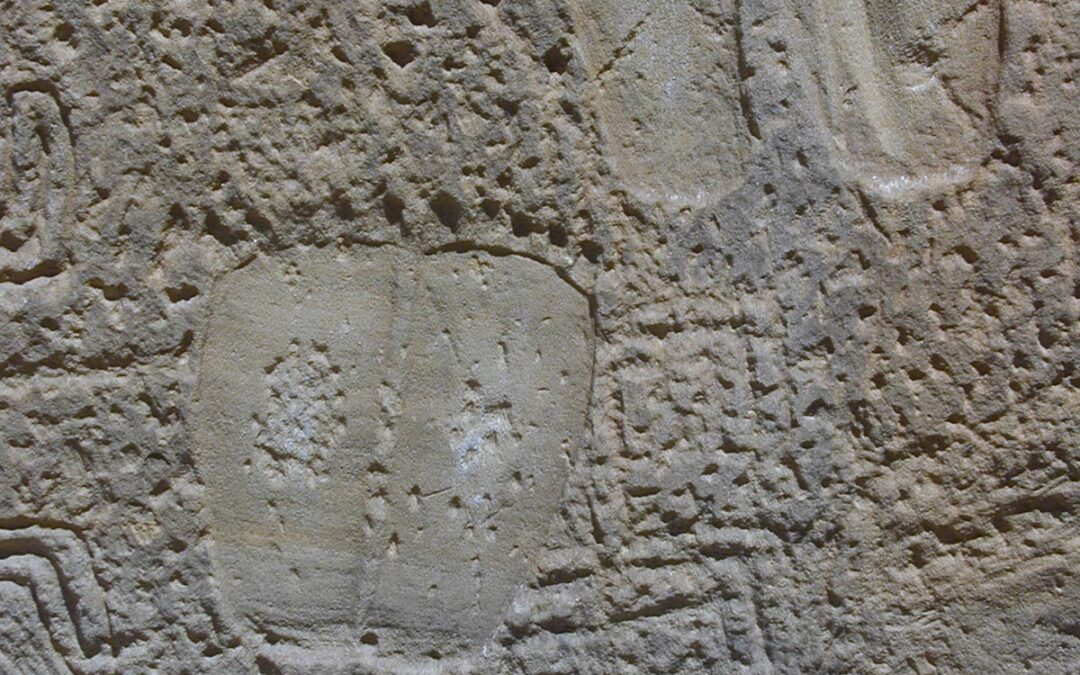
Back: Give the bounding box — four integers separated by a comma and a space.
192, 246, 593, 663
